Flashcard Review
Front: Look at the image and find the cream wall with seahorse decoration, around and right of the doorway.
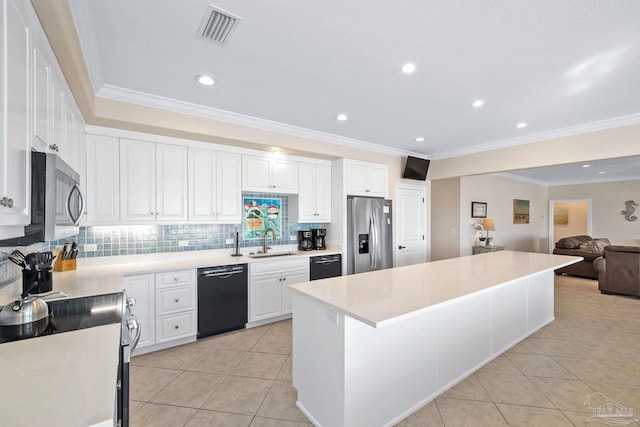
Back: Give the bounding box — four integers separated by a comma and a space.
549, 180, 640, 245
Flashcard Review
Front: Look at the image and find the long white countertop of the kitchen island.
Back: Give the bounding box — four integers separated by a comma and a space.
289, 251, 582, 328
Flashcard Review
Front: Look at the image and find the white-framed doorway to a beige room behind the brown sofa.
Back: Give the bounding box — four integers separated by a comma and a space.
549, 199, 591, 253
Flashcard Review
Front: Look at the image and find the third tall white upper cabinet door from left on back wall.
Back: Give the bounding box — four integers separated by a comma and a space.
156, 144, 188, 221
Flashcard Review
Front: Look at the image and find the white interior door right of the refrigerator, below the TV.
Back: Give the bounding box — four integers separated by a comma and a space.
395, 187, 427, 267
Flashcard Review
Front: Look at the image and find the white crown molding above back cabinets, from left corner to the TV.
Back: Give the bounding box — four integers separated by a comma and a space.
96, 84, 429, 158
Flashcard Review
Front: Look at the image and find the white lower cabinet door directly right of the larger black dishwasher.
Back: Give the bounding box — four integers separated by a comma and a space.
249, 273, 282, 322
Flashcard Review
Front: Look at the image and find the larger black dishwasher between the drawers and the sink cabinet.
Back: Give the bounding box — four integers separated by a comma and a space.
198, 264, 248, 338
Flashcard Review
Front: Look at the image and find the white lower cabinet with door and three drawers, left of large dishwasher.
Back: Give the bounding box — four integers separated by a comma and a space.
124, 270, 198, 355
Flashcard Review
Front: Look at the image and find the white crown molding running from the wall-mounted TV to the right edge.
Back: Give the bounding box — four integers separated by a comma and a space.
430, 113, 640, 160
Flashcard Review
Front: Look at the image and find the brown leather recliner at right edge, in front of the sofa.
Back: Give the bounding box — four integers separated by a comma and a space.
593, 246, 640, 297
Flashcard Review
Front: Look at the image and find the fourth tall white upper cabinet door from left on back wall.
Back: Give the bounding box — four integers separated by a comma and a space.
189, 148, 216, 222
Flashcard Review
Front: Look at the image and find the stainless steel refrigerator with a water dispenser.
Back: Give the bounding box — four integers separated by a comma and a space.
347, 196, 393, 274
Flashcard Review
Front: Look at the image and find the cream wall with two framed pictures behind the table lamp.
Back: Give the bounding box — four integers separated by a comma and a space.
458, 175, 549, 256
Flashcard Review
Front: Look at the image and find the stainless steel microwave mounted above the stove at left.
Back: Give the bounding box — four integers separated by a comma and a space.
0, 151, 85, 246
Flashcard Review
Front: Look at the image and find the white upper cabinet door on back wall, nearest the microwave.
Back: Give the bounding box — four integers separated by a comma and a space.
86, 135, 120, 225
